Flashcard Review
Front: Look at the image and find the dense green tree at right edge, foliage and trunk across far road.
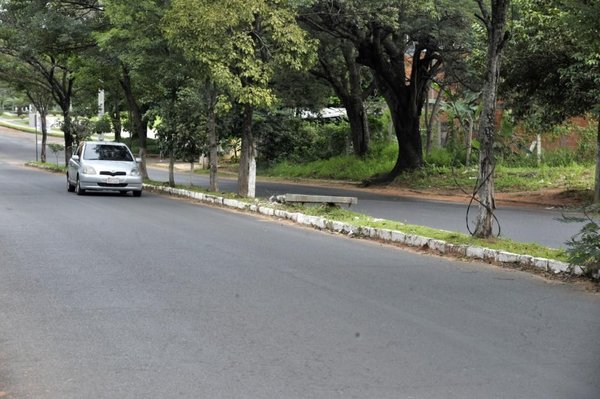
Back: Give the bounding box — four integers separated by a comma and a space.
503, 0, 600, 203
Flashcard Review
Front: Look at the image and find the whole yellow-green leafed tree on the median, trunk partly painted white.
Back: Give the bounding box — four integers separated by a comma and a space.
165, 0, 313, 197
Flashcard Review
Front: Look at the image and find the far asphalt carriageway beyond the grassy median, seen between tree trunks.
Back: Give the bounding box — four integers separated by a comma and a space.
0, 128, 582, 248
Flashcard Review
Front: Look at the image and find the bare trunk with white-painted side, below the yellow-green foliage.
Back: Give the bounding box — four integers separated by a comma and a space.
238, 104, 256, 198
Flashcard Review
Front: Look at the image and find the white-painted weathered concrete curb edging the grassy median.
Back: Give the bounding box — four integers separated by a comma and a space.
144, 184, 584, 276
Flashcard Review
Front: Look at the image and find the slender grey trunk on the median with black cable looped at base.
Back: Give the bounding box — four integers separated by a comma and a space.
473, 0, 510, 238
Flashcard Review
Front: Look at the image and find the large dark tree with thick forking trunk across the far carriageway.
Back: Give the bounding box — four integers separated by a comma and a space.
300, 0, 476, 182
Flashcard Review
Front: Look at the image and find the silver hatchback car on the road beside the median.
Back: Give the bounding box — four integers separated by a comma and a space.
67, 141, 142, 197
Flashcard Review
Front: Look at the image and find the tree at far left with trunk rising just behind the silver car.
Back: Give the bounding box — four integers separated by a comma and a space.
0, 0, 98, 162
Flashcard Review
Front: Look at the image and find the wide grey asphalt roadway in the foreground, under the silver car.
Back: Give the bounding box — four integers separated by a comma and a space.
0, 130, 600, 399
